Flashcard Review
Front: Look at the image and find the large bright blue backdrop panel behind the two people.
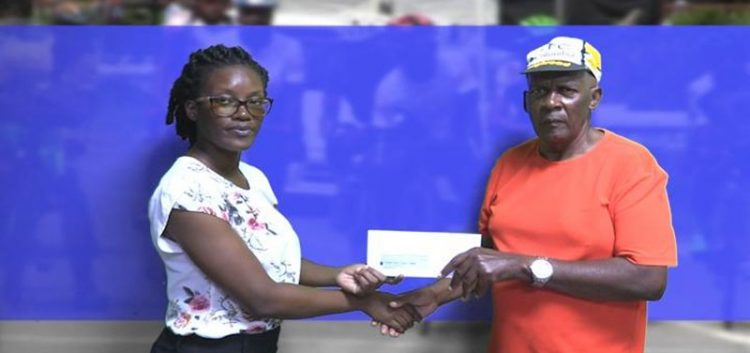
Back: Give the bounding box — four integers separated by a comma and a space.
0, 27, 750, 320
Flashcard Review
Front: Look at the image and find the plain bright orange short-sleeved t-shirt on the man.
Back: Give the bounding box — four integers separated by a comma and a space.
479, 130, 677, 353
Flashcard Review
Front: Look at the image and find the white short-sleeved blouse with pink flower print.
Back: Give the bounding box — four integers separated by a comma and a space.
149, 156, 301, 338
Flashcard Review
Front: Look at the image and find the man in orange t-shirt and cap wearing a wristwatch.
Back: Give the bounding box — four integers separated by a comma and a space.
381, 37, 677, 353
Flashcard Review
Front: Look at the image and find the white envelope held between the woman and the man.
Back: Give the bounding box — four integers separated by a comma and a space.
367, 230, 482, 278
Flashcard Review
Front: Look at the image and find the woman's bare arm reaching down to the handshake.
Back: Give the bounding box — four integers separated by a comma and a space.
165, 210, 421, 330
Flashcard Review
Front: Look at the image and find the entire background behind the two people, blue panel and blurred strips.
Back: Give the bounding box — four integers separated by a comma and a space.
0, 0, 750, 353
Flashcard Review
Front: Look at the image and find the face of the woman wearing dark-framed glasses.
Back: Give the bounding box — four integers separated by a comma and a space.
185, 65, 266, 152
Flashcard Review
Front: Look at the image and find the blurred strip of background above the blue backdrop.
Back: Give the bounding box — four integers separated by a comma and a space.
0, 0, 750, 25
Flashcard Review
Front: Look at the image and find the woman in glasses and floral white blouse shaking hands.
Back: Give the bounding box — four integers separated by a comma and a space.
149, 45, 421, 353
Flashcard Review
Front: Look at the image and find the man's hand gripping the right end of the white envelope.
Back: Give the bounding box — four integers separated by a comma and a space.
441, 248, 530, 299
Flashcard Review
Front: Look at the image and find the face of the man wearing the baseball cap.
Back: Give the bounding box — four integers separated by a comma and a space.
524, 71, 602, 144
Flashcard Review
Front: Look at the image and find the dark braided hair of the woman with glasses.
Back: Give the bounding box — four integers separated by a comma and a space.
167, 44, 269, 146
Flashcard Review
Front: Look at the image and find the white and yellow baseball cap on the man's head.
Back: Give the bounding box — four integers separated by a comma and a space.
523, 37, 602, 82
